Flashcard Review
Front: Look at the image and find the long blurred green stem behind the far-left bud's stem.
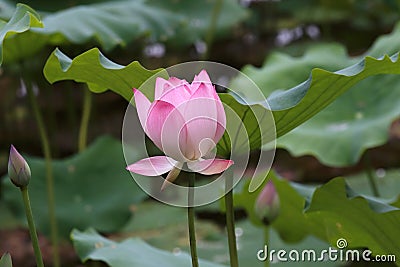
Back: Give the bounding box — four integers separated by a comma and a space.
26, 84, 60, 267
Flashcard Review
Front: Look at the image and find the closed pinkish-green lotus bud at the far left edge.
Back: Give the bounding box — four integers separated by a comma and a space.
8, 145, 31, 187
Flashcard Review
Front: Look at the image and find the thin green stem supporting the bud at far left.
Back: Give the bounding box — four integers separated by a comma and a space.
20, 186, 44, 267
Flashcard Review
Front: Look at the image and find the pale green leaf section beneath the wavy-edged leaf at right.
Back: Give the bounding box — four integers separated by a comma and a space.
278, 75, 400, 166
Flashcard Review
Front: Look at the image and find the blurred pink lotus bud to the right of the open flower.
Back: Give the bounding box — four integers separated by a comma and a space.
254, 181, 280, 225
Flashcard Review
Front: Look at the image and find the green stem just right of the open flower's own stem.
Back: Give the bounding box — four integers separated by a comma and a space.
225, 176, 239, 267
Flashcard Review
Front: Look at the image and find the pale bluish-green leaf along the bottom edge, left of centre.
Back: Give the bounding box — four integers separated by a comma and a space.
71, 229, 223, 267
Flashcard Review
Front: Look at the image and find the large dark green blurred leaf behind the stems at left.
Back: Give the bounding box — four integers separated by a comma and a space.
2, 137, 147, 240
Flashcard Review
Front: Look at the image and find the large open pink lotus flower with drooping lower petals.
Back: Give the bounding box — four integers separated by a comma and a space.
127, 70, 233, 187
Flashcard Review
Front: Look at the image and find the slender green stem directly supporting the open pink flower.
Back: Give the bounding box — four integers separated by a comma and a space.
188, 173, 199, 267
